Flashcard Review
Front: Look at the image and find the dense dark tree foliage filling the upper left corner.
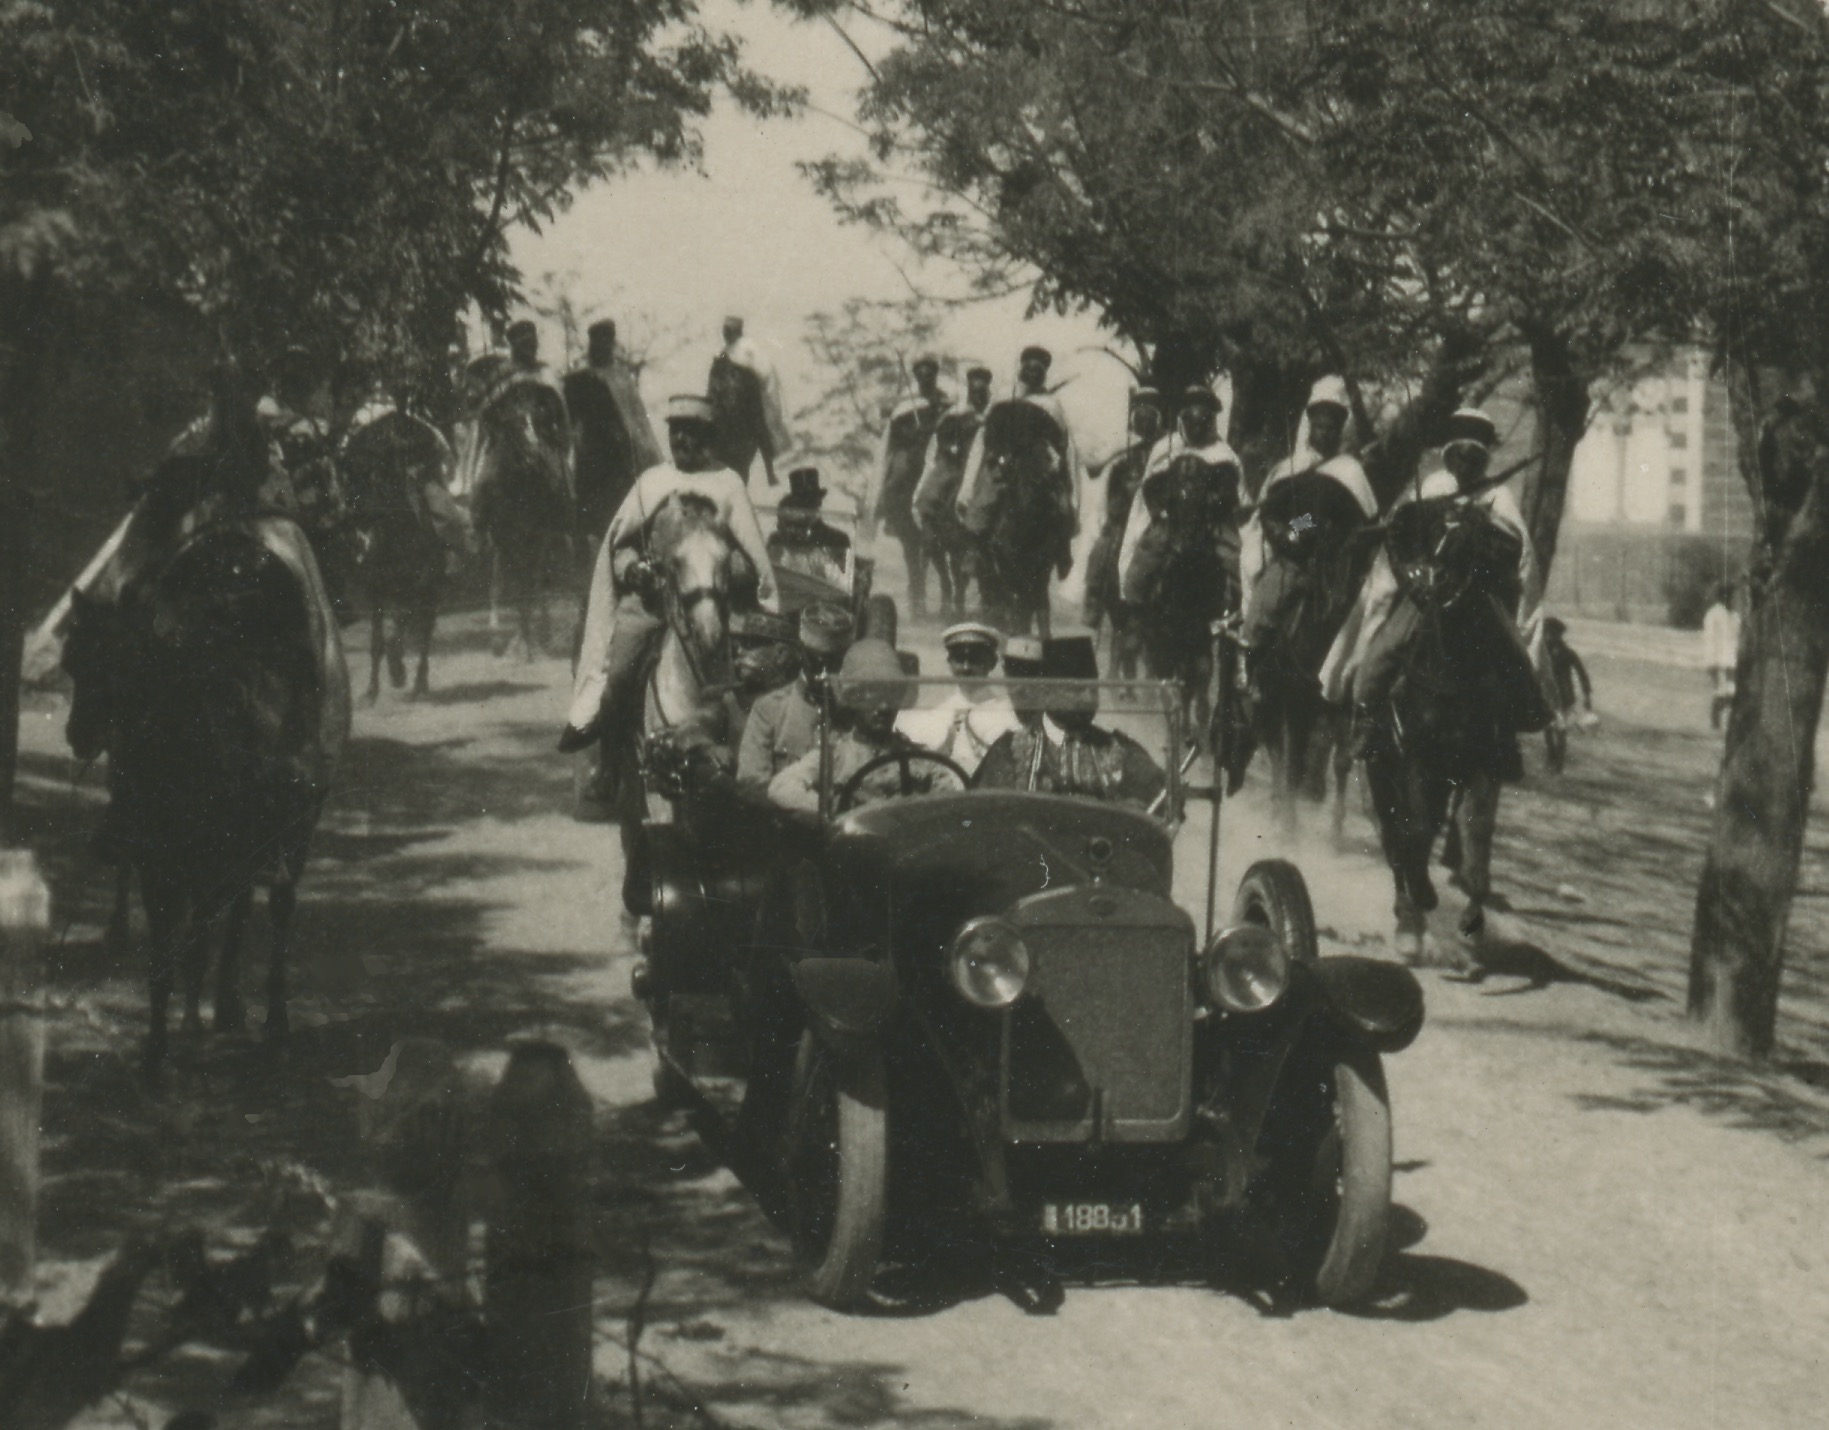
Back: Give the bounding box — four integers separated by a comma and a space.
0, 0, 786, 391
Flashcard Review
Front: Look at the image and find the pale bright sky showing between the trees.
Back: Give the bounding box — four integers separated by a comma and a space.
512, 0, 1130, 475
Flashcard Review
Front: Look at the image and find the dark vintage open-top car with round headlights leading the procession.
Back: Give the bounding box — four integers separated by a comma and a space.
638, 682, 1423, 1307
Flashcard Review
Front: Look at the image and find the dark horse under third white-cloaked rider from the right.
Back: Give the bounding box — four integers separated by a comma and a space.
1123, 452, 1238, 749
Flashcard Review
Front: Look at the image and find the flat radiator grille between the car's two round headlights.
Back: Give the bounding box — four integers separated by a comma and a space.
1002, 925, 1193, 1143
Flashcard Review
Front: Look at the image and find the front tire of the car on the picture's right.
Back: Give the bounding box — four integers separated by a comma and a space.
1273, 1048, 1392, 1306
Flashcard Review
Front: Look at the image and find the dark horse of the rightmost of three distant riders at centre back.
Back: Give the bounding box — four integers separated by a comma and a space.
960, 399, 1074, 638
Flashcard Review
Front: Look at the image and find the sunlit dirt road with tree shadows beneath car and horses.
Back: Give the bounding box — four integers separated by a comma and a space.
26, 624, 1829, 1430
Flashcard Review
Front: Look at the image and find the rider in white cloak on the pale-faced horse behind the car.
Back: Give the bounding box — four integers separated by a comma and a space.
560, 397, 775, 753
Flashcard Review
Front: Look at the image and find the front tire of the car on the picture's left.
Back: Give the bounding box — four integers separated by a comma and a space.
786, 1031, 889, 1311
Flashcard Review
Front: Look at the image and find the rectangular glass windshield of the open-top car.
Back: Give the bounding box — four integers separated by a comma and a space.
821, 675, 1189, 825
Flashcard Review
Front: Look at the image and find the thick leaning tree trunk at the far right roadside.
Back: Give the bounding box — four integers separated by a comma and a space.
1690, 377, 1829, 1059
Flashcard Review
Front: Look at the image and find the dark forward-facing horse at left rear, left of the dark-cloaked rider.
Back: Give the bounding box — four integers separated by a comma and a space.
470, 358, 576, 660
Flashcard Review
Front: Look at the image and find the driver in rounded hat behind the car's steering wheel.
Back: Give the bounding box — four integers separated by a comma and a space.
768, 636, 960, 814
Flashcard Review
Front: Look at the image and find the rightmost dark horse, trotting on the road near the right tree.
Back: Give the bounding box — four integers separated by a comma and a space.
1357, 499, 1547, 956
